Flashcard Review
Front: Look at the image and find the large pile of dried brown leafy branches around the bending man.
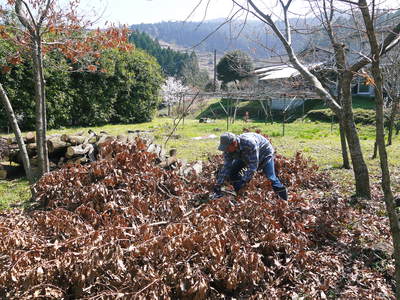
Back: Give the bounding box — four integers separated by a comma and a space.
0, 140, 393, 299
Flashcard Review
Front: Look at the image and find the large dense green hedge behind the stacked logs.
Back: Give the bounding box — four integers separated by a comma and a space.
0, 43, 162, 130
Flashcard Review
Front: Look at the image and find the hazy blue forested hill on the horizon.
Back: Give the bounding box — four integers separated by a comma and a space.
131, 10, 400, 61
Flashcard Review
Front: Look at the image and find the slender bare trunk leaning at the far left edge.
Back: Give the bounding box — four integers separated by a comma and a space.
0, 83, 34, 184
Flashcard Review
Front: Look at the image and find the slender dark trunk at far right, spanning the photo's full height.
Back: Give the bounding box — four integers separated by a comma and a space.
358, 0, 400, 299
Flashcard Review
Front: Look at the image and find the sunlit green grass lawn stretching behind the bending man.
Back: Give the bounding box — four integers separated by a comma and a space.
0, 118, 400, 208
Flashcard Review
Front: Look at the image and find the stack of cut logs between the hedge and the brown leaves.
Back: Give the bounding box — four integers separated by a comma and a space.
0, 130, 202, 179
